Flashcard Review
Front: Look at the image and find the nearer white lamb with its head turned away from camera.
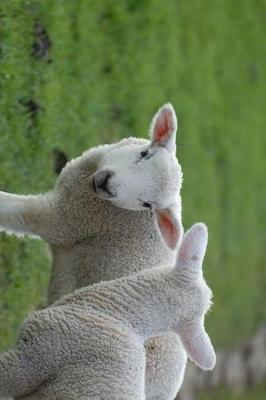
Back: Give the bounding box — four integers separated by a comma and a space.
0, 224, 216, 400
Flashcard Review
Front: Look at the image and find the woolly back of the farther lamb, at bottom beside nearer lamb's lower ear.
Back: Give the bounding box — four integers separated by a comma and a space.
145, 333, 187, 400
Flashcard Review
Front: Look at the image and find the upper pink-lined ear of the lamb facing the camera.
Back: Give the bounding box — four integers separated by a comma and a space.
150, 103, 177, 154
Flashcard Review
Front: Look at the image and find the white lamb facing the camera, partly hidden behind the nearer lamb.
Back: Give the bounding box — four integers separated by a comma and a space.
0, 104, 186, 400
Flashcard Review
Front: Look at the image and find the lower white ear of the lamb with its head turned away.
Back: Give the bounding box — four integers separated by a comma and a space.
178, 320, 216, 371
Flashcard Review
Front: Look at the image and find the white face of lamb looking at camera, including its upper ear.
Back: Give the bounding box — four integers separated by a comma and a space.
90, 104, 182, 210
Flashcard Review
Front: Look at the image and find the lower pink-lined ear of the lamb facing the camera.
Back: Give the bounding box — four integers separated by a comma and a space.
154, 207, 183, 250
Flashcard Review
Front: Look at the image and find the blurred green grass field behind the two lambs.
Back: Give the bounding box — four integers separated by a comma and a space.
0, 0, 266, 399
